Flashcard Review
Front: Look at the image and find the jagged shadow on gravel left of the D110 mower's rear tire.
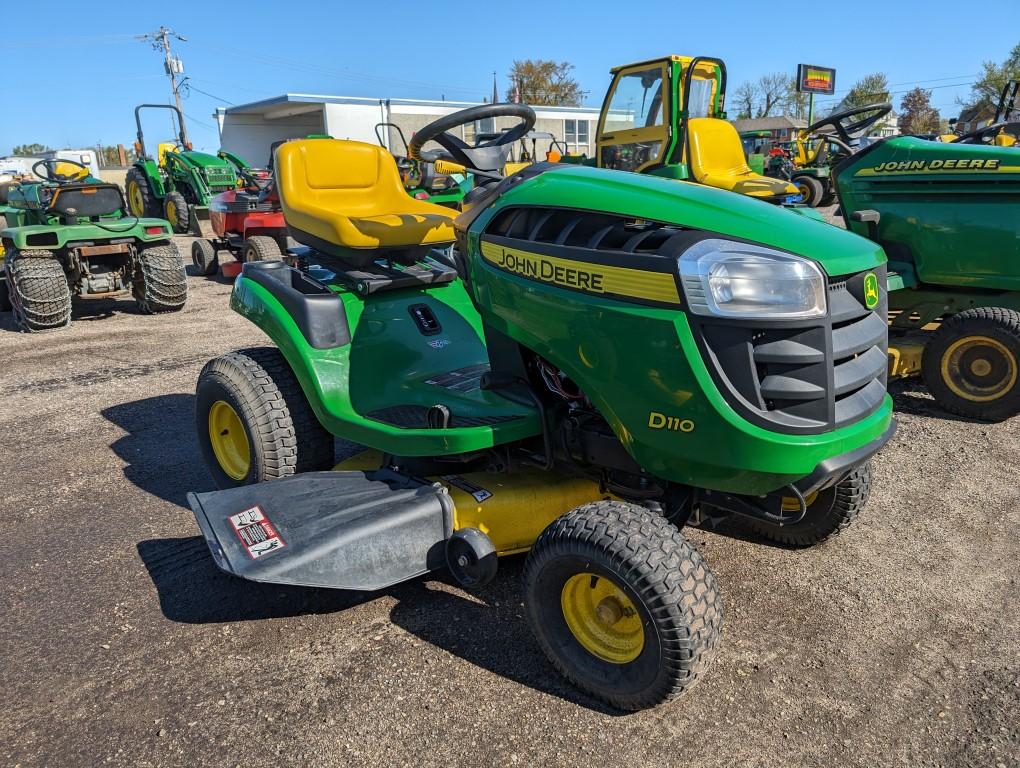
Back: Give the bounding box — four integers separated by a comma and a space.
102, 394, 216, 509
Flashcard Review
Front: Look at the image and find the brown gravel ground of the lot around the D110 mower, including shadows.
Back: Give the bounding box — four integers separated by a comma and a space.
0, 224, 1020, 768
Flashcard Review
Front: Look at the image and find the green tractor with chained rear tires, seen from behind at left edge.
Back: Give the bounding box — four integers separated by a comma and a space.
0, 160, 188, 330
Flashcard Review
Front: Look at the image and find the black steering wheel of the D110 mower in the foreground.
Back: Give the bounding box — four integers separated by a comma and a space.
407, 104, 536, 178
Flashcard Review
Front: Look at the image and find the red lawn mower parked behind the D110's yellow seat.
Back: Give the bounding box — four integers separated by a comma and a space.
192, 152, 288, 277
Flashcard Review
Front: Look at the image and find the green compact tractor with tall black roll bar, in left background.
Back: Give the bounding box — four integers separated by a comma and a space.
124, 104, 238, 236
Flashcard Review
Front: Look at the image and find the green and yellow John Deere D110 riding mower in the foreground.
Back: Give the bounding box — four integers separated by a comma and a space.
189, 104, 895, 709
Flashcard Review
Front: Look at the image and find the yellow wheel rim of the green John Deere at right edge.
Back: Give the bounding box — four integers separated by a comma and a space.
941, 336, 1020, 403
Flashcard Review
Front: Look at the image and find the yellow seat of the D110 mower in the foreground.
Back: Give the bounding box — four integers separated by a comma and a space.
274, 139, 456, 265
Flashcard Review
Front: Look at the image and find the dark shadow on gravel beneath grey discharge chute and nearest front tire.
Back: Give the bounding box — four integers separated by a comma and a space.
138, 536, 625, 715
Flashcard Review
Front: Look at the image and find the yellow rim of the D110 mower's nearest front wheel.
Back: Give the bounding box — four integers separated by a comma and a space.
560, 573, 645, 664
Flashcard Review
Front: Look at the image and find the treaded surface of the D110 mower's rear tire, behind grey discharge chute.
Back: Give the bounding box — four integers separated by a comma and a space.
198, 347, 334, 481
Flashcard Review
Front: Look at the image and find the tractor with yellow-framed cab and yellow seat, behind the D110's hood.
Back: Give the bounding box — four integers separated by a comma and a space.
564, 56, 800, 204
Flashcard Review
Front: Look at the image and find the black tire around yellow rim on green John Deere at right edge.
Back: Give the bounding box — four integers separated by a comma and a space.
921, 307, 1020, 421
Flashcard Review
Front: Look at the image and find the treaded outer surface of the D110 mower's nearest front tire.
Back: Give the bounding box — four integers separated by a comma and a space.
524, 501, 724, 710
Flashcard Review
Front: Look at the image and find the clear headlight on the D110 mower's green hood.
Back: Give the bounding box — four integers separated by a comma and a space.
678, 239, 825, 319
